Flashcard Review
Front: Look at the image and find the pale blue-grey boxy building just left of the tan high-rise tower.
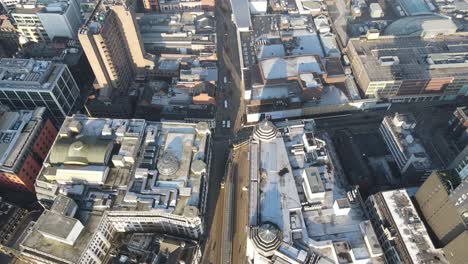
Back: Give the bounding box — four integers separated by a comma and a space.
37, 0, 82, 40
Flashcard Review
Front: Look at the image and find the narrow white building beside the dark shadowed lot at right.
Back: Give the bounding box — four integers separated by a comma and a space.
379, 113, 431, 182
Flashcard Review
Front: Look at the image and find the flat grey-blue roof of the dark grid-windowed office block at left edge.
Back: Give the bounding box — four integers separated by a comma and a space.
0, 58, 65, 90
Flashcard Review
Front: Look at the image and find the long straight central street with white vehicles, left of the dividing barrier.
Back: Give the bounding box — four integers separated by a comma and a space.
202, 0, 243, 264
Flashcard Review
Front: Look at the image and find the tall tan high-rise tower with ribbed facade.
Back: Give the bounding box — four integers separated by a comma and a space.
78, 0, 154, 95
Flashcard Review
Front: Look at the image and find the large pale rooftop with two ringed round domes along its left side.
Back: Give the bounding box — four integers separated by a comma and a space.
248, 120, 384, 263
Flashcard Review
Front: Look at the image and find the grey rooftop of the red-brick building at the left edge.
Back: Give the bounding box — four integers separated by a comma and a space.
0, 108, 45, 172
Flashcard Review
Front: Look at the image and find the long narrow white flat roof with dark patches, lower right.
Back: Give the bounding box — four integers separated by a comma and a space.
382, 190, 444, 263
